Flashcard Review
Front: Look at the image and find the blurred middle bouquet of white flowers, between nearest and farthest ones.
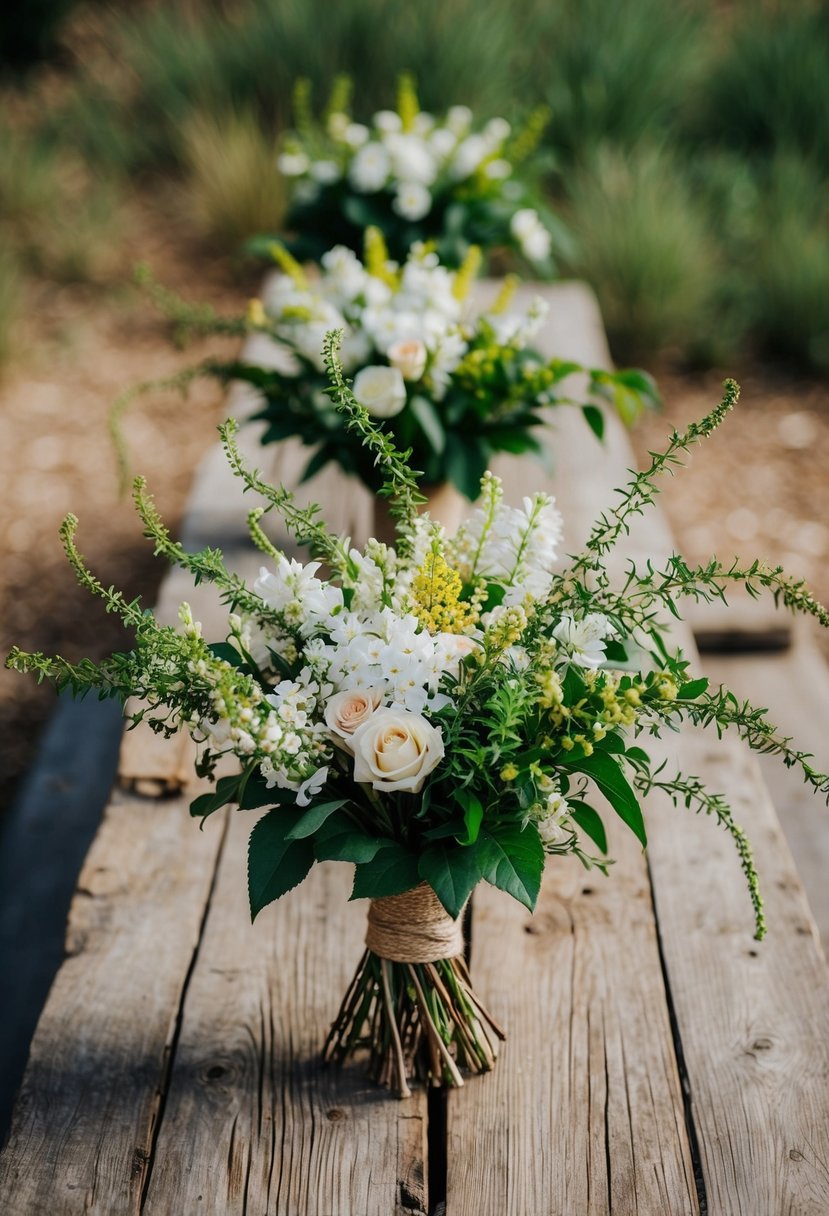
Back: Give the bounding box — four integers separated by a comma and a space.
146, 229, 658, 500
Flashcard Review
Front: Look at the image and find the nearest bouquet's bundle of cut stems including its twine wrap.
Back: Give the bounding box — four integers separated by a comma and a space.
323, 884, 506, 1098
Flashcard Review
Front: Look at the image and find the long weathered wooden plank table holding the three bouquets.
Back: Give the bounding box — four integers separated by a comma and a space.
0, 285, 829, 1216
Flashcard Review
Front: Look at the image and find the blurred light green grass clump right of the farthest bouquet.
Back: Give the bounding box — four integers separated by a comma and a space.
561, 147, 718, 360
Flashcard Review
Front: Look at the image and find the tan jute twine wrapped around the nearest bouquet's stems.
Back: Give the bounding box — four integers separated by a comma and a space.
366, 883, 463, 963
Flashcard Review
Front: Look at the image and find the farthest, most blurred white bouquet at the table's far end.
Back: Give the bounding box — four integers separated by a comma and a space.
253, 77, 569, 277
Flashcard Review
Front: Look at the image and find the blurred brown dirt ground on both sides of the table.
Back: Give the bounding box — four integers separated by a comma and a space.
0, 231, 829, 806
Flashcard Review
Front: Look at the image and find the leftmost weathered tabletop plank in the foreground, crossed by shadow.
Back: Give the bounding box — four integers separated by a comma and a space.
0, 795, 222, 1216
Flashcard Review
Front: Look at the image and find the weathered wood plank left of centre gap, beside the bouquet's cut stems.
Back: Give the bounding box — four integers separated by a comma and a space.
145, 815, 428, 1216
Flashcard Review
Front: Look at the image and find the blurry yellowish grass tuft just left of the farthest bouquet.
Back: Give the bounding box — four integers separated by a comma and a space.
181, 111, 284, 250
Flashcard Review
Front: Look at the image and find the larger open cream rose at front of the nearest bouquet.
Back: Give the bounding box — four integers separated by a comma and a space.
351, 709, 444, 794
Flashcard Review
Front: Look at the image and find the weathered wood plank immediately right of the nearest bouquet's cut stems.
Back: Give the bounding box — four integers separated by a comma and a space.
446, 816, 699, 1216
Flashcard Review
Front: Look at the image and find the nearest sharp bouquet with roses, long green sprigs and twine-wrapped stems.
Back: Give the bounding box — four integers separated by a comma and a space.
7, 336, 829, 1094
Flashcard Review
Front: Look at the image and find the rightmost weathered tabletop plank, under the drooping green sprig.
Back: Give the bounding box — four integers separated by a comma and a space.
641, 737, 829, 1216
